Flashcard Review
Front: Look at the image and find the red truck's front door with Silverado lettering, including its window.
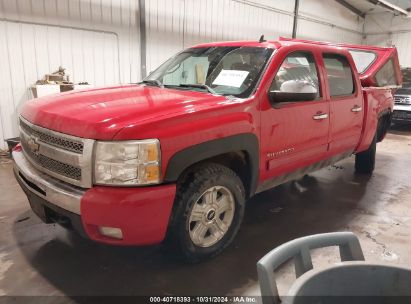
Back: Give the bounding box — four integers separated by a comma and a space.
261, 51, 330, 182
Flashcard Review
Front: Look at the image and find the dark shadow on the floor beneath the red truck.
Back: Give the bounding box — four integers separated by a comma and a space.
13, 156, 394, 302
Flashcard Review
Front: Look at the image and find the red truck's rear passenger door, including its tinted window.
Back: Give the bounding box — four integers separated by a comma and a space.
322, 51, 364, 155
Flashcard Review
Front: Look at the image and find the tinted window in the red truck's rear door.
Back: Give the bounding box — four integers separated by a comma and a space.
323, 54, 355, 97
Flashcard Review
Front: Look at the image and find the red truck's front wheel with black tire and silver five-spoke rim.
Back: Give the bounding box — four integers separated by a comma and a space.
168, 164, 245, 263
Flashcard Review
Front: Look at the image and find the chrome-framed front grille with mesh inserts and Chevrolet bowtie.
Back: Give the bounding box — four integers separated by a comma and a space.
20, 118, 94, 188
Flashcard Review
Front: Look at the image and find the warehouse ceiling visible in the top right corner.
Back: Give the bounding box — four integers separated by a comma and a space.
336, 0, 411, 17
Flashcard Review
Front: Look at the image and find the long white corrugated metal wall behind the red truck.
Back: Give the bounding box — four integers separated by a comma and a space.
0, 0, 361, 148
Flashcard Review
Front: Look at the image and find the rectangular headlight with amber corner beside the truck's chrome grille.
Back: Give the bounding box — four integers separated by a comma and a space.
94, 139, 160, 186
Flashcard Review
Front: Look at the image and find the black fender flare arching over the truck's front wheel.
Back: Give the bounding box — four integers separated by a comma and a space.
164, 133, 260, 196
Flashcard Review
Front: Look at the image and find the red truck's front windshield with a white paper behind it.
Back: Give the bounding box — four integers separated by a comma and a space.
144, 47, 273, 98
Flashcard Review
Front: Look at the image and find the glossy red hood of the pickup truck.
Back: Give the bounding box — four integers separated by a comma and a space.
21, 85, 226, 140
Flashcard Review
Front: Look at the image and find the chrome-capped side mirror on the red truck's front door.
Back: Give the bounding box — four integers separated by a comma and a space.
268, 80, 318, 105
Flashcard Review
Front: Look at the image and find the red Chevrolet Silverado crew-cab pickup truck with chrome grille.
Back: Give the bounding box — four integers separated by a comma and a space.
13, 38, 401, 262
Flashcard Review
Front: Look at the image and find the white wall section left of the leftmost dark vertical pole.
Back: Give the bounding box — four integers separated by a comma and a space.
0, 0, 140, 148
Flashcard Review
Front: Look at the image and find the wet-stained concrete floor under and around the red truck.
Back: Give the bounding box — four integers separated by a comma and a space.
0, 125, 411, 301
